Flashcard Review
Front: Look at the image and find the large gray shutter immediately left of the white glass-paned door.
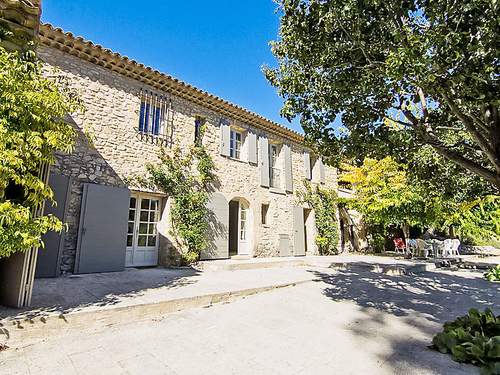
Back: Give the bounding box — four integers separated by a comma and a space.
75, 184, 130, 273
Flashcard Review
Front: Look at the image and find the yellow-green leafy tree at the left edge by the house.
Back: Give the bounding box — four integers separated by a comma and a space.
0, 29, 80, 258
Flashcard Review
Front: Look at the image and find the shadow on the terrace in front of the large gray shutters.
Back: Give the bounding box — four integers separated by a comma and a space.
0, 268, 198, 319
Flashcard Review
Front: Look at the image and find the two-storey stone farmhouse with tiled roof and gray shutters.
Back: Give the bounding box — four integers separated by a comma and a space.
29, 24, 344, 276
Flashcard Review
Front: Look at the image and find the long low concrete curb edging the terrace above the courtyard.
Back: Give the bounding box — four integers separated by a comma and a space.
0, 277, 314, 348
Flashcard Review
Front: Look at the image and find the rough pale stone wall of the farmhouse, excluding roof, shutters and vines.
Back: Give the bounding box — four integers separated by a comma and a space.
38, 46, 336, 272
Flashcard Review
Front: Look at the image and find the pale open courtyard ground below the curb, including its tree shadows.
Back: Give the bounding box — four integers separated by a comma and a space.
0, 268, 500, 375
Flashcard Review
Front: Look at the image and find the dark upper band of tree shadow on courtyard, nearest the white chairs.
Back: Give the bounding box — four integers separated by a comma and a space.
314, 270, 500, 322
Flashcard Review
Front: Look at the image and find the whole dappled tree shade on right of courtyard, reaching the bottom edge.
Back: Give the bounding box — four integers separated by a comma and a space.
312, 270, 500, 375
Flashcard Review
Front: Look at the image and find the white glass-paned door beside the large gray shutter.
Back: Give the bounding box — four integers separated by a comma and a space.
125, 194, 160, 267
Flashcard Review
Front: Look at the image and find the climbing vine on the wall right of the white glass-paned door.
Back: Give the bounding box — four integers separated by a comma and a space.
146, 125, 216, 264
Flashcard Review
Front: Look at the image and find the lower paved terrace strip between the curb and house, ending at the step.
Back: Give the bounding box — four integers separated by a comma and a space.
0, 267, 313, 318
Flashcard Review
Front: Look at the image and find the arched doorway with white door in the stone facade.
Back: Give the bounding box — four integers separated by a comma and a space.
229, 198, 252, 256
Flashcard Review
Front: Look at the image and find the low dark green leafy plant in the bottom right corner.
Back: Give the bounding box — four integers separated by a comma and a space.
432, 309, 500, 374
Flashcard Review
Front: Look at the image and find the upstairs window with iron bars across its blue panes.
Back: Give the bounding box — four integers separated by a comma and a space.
138, 90, 173, 145
